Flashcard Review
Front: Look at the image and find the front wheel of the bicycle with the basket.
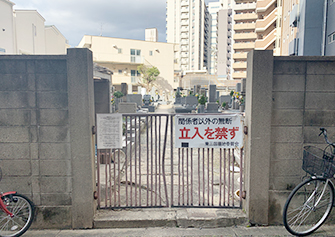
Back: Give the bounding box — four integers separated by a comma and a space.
283, 178, 334, 236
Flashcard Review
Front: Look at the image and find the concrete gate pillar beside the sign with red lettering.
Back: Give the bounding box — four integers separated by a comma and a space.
244, 50, 273, 225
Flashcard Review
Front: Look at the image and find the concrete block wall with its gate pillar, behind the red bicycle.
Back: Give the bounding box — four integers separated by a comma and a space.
0, 49, 95, 228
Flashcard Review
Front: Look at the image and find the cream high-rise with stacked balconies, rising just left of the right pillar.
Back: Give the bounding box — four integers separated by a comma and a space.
232, 0, 258, 80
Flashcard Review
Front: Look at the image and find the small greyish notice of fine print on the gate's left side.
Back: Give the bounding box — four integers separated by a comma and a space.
97, 114, 122, 149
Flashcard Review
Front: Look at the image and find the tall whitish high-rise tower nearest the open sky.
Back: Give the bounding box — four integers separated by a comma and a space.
166, 0, 211, 71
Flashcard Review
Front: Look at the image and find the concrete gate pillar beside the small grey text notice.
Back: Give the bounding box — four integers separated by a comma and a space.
67, 48, 96, 229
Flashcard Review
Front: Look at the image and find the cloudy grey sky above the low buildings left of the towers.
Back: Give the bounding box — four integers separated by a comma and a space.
11, 0, 216, 46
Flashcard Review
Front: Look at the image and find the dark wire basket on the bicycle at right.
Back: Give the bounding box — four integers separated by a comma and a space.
302, 146, 335, 178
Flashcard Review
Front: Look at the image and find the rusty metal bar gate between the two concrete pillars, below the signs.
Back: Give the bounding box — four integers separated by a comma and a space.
96, 114, 243, 208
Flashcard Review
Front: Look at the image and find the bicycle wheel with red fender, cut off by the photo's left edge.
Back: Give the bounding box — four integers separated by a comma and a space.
0, 193, 34, 237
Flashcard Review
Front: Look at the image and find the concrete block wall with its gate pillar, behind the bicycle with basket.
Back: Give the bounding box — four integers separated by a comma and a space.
244, 51, 335, 224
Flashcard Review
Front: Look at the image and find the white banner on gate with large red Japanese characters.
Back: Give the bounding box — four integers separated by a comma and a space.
175, 114, 243, 148
